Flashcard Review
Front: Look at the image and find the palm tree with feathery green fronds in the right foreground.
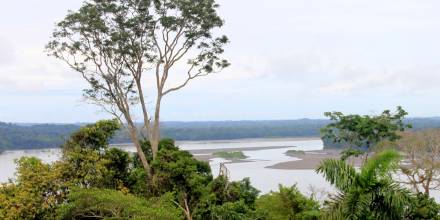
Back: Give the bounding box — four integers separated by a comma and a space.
316, 150, 411, 219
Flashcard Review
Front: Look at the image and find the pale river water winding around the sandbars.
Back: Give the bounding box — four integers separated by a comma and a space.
0, 138, 440, 202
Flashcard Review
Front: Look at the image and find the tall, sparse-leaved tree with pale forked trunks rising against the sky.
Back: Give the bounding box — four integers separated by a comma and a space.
46, 0, 229, 174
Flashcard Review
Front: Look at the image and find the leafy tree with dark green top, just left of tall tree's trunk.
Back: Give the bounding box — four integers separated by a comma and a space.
60, 120, 127, 188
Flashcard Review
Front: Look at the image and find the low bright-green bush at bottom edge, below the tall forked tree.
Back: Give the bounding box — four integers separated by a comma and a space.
57, 189, 182, 220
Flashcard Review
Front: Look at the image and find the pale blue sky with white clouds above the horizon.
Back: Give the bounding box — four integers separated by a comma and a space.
0, 0, 440, 123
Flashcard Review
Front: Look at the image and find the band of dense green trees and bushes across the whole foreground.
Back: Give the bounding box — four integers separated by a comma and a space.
0, 116, 440, 220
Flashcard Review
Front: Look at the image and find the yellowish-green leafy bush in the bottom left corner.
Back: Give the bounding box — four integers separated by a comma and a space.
0, 157, 67, 219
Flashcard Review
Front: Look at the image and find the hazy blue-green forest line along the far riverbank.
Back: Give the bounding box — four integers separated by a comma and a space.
0, 117, 440, 150
